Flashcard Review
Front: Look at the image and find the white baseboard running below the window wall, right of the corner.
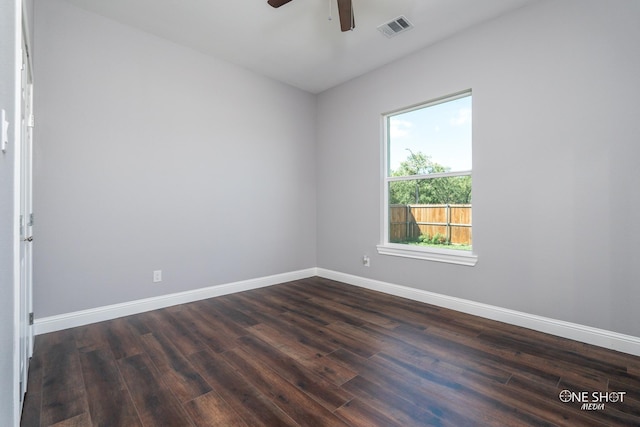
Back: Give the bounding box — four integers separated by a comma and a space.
318, 268, 640, 356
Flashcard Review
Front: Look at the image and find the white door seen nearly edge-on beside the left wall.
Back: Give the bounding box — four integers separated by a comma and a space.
19, 28, 33, 406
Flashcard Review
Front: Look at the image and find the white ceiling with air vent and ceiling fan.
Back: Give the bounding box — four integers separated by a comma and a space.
67, 0, 537, 93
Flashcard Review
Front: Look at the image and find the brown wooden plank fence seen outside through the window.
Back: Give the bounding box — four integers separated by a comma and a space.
389, 205, 472, 245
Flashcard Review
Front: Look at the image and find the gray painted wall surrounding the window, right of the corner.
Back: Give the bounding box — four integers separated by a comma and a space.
317, 0, 640, 336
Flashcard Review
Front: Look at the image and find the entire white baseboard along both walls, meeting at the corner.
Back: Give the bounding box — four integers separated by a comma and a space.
34, 268, 640, 356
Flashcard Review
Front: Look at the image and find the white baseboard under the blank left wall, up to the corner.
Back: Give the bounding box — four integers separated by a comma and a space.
33, 268, 317, 335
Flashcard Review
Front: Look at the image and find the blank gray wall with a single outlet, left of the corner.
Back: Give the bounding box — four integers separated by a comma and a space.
34, 0, 316, 317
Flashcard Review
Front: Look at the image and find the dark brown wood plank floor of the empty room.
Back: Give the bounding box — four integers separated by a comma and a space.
22, 278, 640, 427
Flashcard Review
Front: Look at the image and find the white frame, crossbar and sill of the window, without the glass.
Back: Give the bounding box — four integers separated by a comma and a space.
377, 90, 478, 266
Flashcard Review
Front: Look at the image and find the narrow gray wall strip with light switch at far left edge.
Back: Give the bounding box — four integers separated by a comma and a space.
0, 0, 17, 426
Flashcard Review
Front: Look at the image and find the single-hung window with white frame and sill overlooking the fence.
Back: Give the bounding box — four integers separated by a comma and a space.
378, 91, 477, 265
